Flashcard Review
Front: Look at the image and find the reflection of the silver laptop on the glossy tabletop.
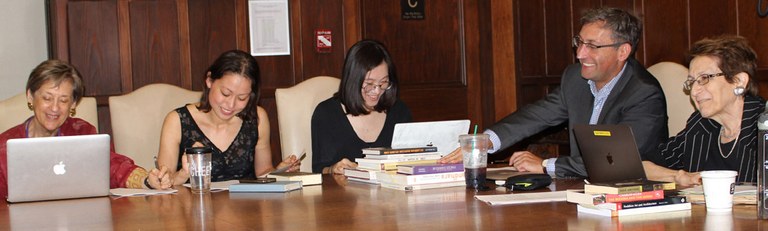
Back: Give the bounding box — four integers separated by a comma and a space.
8, 197, 113, 230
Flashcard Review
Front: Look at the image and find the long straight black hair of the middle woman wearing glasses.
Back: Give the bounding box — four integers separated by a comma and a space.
335, 40, 398, 116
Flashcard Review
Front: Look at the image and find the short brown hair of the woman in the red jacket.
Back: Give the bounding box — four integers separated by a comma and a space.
27, 59, 85, 105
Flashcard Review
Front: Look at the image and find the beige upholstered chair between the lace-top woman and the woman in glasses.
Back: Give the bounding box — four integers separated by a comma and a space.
275, 76, 340, 172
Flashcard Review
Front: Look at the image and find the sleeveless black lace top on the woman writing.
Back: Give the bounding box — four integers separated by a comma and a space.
176, 106, 259, 181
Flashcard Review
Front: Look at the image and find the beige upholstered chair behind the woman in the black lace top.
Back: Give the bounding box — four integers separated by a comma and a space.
109, 83, 202, 169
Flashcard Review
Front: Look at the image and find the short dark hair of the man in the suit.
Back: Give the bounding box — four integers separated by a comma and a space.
581, 7, 643, 56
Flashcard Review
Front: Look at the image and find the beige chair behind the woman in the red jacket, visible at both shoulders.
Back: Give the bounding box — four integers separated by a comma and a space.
0, 93, 99, 133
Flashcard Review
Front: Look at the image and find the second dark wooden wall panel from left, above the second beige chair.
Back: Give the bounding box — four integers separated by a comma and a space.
126, 1, 185, 89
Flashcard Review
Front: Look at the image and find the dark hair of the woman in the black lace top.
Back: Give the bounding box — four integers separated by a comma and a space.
197, 50, 261, 121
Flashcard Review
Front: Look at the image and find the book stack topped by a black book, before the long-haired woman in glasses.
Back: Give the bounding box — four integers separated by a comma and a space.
344, 147, 442, 184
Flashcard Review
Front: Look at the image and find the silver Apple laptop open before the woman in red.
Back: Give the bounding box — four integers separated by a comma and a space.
7, 134, 109, 202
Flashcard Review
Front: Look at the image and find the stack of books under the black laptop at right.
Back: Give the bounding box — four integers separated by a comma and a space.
566, 181, 691, 217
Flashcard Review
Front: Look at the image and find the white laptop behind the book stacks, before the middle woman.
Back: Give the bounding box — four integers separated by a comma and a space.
392, 120, 469, 154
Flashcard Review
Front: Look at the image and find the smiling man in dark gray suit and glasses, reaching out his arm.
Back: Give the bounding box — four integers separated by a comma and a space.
441, 8, 667, 178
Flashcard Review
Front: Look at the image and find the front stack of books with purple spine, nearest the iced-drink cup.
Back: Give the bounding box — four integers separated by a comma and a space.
376, 163, 466, 191
